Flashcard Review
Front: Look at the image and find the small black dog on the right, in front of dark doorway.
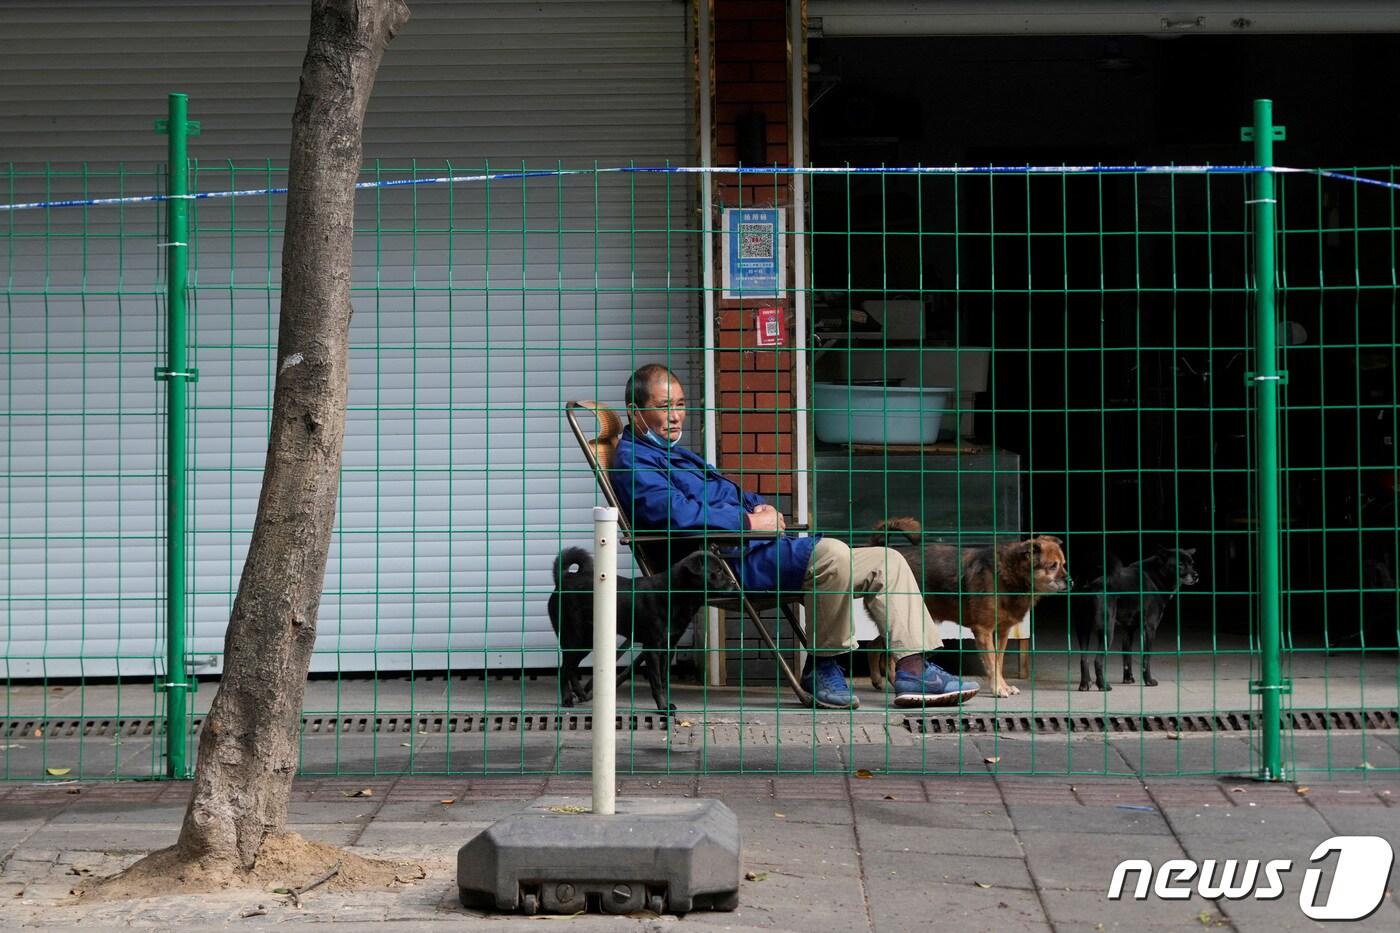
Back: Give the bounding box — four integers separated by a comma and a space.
1074, 548, 1200, 691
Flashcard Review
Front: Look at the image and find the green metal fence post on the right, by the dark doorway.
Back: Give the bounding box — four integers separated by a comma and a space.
1242, 99, 1288, 780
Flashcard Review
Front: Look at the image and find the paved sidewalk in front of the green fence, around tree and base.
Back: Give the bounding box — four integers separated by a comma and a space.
0, 775, 1400, 933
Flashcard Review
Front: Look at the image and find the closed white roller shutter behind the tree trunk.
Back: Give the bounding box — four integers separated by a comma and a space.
0, 0, 700, 677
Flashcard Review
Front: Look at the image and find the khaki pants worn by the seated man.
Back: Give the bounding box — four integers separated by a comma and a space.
802, 538, 942, 658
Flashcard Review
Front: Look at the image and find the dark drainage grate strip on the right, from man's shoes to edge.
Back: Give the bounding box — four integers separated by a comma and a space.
904, 709, 1400, 734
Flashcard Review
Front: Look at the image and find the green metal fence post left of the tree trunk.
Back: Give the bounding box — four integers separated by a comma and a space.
155, 94, 199, 778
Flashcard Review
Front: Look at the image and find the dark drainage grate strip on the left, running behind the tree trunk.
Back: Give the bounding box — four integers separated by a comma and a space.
0, 713, 669, 740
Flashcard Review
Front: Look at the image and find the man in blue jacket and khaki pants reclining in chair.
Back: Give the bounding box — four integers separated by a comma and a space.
608, 363, 977, 709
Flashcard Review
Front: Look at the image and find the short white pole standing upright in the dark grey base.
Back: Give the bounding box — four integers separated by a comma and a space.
594, 506, 617, 815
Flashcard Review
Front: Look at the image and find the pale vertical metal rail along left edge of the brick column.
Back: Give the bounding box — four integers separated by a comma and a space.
696, 0, 724, 686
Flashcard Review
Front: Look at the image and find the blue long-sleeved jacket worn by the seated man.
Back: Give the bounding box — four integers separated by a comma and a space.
608, 426, 820, 593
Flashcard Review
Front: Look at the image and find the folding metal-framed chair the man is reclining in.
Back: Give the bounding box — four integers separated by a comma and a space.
564, 402, 812, 706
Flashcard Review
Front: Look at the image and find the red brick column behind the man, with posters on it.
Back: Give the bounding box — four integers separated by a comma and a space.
714, 0, 801, 501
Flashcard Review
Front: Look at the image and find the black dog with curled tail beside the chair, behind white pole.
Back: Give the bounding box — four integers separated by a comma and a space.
549, 548, 735, 712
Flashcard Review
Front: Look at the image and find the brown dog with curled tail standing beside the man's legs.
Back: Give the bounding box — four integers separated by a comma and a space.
871, 518, 1070, 696
